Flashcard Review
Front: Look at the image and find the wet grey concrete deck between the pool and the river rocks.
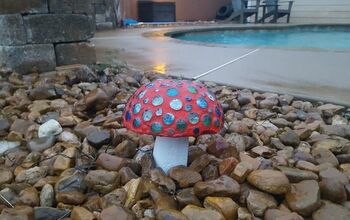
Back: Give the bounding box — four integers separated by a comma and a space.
92, 25, 350, 106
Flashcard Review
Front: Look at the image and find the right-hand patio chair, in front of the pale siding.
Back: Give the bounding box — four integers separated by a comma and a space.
259, 0, 293, 23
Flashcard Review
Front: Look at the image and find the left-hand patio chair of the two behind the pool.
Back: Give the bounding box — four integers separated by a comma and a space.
226, 0, 260, 24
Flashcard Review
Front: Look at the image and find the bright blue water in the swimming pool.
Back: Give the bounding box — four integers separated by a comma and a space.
174, 27, 350, 49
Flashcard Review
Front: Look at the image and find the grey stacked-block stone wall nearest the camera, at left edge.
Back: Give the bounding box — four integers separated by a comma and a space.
0, 0, 96, 74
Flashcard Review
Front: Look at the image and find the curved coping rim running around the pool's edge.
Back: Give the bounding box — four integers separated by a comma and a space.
142, 23, 350, 53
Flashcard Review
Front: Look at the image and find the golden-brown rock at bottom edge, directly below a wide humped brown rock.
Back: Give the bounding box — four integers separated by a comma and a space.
203, 197, 239, 219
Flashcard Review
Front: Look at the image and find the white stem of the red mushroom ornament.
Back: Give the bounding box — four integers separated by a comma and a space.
153, 137, 188, 174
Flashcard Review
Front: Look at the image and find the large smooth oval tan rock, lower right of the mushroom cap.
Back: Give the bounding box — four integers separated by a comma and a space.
247, 170, 290, 195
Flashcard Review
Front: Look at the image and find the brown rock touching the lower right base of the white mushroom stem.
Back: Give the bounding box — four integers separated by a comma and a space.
169, 166, 202, 188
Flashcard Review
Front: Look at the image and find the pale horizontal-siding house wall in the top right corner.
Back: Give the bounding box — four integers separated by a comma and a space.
291, 0, 350, 23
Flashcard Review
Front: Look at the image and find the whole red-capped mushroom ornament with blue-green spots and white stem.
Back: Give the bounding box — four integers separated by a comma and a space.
123, 80, 224, 173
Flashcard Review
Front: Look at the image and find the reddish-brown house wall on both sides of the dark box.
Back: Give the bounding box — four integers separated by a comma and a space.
122, 0, 231, 21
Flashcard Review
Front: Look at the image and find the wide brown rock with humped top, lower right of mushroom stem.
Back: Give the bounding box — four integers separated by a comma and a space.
194, 175, 240, 198
